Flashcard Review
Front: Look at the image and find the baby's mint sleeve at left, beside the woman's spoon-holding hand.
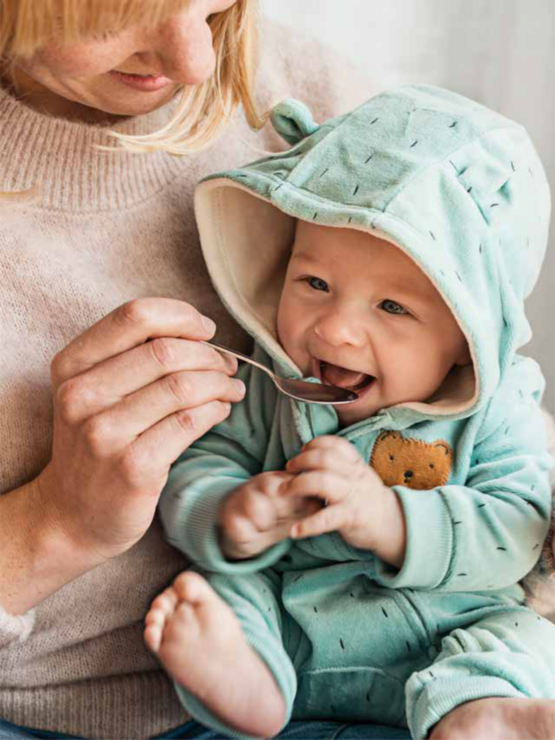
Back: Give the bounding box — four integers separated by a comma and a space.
159, 350, 291, 574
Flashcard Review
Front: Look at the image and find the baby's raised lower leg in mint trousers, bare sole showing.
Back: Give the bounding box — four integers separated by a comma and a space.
145, 571, 296, 737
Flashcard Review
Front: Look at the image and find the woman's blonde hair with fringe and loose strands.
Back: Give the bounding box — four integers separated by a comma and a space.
0, 0, 265, 155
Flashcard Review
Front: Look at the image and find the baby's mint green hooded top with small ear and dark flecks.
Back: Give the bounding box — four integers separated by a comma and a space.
160, 86, 551, 737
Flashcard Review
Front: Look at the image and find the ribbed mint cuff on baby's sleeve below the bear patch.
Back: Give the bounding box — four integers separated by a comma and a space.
376, 486, 453, 589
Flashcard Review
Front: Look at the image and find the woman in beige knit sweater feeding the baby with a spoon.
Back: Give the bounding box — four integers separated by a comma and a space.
0, 0, 552, 740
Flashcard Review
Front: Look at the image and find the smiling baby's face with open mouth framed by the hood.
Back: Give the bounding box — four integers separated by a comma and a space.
278, 221, 470, 425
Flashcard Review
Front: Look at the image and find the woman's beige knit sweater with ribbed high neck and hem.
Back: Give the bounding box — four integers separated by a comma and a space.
0, 23, 375, 740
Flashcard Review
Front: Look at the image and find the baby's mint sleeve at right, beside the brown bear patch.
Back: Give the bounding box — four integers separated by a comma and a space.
377, 360, 552, 591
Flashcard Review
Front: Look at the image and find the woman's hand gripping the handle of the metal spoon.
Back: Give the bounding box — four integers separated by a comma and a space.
37, 298, 244, 567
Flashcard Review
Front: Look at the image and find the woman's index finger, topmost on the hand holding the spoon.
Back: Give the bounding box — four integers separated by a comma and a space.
52, 298, 215, 387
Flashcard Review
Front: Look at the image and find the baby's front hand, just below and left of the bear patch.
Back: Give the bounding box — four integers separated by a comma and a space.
281, 436, 404, 561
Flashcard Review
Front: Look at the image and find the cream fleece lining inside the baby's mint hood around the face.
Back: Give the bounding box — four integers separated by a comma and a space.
195, 178, 478, 416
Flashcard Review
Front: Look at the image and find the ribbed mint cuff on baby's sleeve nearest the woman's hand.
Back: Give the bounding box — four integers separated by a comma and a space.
168, 479, 291, 575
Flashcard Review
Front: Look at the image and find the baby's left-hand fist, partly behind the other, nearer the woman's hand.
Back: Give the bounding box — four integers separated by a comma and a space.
219, 471, 321, 560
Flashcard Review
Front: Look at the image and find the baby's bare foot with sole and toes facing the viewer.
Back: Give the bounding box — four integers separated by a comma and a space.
144, 571, 286, 737
